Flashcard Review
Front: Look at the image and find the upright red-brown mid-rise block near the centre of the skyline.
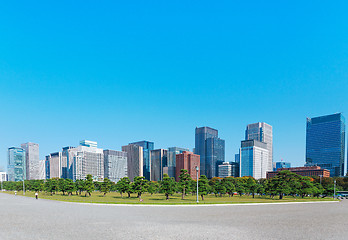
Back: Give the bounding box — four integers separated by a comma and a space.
175, 151, 201, 181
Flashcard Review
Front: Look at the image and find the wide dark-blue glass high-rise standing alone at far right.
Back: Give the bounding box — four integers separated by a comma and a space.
306, 113, 345, 177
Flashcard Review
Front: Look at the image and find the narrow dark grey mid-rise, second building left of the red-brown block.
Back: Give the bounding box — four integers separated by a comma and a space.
150, 149, 168, 181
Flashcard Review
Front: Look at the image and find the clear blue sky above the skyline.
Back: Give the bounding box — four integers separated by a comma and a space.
0, 0, 348, 171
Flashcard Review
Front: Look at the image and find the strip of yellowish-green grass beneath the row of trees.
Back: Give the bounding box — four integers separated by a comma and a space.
0, 191, 335, 205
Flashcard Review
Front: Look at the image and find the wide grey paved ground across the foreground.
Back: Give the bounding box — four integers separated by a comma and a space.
0, 193, 348, 240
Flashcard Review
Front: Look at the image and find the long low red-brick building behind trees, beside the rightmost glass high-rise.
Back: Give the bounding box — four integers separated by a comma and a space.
267, 166, 330, 179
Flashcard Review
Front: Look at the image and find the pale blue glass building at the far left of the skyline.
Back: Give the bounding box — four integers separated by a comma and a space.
7, 147, 26, 182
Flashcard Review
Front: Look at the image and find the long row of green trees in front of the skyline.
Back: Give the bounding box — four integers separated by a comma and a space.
2, 169, 348, 200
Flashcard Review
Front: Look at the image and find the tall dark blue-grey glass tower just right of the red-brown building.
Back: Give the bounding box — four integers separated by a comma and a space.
195, 127, 225, 178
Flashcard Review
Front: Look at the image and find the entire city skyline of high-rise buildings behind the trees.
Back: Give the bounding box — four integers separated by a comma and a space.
0, 113, 345, 182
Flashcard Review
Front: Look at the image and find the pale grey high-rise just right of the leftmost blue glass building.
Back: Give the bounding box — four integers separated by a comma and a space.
21, 142, 40, 180
